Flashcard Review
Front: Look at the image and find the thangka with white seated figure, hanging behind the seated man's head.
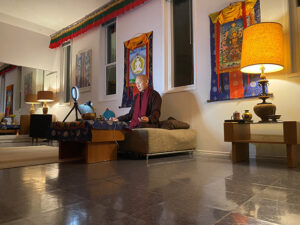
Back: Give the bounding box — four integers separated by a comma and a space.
121, 31, 153, 108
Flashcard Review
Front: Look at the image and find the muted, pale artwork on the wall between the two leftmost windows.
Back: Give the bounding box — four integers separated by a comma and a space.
75, 49, 92, 91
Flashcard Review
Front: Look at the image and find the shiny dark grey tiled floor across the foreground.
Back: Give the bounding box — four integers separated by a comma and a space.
0, 155, 300, 225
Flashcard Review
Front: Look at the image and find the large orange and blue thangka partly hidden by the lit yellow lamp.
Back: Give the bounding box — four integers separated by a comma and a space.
209, 0, 261, 101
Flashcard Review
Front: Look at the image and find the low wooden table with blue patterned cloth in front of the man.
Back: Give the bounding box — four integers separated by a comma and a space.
49, 121, 128, 163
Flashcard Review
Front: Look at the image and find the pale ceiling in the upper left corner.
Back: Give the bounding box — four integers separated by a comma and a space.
0, 0, 110, 35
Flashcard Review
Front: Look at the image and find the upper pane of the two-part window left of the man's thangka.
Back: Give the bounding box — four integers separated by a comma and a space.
107, 23, 116, 64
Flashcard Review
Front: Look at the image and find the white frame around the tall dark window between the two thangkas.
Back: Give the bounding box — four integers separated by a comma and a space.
164, 0, 198, 93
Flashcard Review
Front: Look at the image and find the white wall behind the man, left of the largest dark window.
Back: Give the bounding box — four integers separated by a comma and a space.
60, 0, 164, 120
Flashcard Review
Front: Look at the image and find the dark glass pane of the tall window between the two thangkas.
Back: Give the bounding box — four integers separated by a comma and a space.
173, 0, 194, 87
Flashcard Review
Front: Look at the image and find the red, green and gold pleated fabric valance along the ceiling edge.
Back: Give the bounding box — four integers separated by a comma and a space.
49, 0, 149, 48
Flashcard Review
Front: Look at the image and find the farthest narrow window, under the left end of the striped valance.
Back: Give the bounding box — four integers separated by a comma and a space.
60, 41, 71, 102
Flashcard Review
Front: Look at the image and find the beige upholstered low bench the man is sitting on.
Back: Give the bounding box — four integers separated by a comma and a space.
119, 128, 196, 160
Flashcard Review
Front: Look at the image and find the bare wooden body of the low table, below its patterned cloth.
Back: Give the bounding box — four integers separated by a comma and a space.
59, 129, 125, 163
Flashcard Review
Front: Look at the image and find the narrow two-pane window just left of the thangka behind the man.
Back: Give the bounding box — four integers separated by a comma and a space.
105, 21, 116, 95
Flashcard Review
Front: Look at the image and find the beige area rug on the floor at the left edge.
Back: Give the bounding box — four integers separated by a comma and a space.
0, 145, 60, 169
